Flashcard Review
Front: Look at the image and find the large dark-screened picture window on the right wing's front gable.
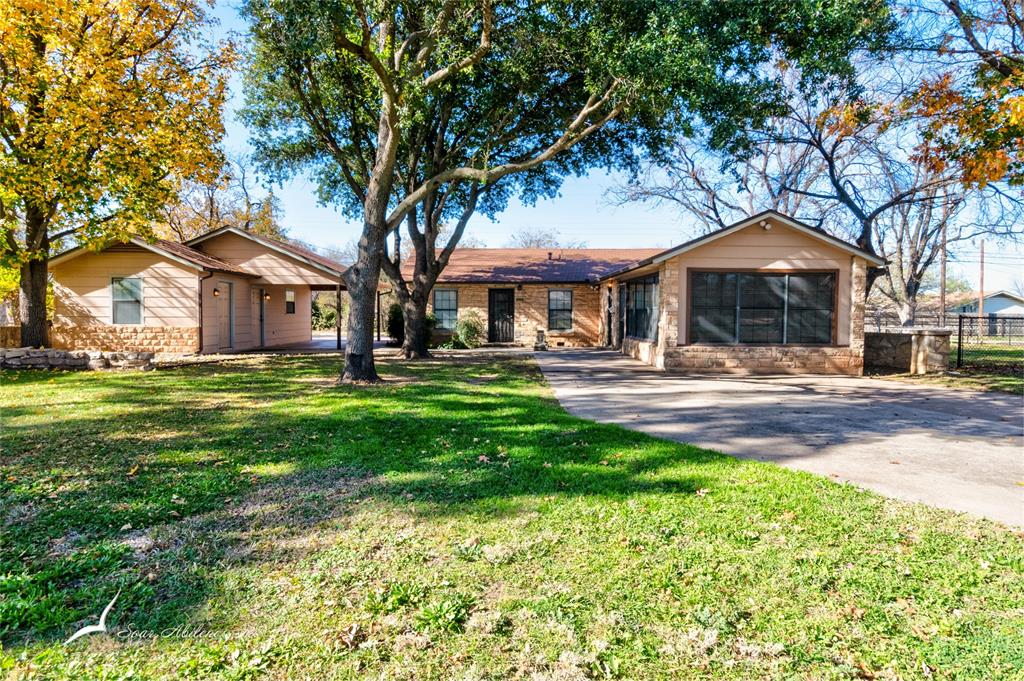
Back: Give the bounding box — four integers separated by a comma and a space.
690, 272, 836, 345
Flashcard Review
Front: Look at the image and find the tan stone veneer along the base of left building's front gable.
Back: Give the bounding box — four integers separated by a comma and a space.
50, 325, 199, 354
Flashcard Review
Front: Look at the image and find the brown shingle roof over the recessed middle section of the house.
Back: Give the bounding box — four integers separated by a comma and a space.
406, 248, 660, 284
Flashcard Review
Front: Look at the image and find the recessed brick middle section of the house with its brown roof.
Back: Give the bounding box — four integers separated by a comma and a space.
419, 248, 658, 347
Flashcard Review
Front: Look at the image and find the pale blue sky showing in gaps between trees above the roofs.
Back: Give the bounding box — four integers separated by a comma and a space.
214, 0, 1024, 291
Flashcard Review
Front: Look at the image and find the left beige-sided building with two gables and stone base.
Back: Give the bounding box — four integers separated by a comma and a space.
50, 227, 345, 353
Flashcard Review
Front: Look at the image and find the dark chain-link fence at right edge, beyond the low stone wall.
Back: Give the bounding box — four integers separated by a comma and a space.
949, 314, 1024, 373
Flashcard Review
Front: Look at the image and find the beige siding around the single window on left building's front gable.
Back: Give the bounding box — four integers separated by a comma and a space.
50, 248, 200, 327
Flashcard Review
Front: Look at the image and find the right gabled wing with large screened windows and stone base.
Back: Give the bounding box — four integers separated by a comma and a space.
601, 211, 884, 375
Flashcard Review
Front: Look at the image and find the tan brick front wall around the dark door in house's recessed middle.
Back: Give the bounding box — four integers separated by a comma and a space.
428, 284, 600, 347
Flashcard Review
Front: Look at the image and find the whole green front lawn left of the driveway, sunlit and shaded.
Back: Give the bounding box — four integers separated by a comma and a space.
0, 356, 1024, 681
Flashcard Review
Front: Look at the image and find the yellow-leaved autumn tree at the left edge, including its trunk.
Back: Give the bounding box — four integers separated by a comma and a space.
0, 0, 234, 345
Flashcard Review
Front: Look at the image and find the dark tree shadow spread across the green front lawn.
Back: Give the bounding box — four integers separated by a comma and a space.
0, 355, 1003, 643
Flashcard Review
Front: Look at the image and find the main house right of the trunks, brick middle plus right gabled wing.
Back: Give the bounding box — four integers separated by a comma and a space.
417, 211, 885, 375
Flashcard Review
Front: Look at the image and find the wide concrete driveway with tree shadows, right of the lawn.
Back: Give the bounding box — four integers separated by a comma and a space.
537, 350, 1024, 525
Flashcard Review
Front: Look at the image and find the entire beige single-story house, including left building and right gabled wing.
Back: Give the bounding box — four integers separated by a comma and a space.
41, 211, 884, 375
